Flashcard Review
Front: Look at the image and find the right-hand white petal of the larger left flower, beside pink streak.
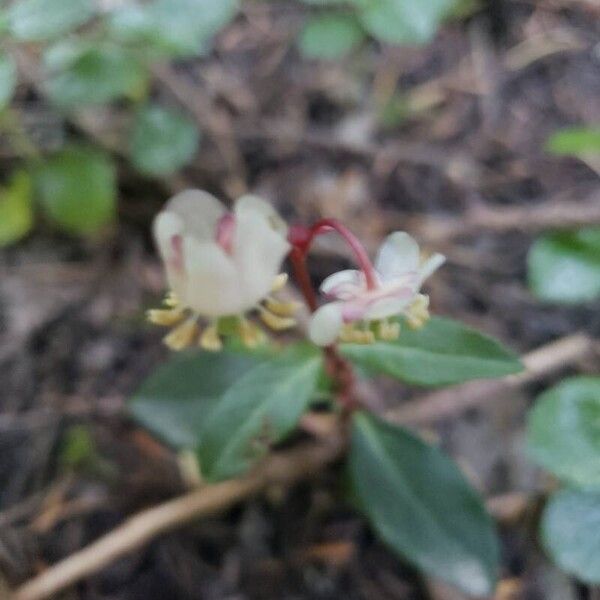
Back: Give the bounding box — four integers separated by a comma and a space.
232, 206, 290, 306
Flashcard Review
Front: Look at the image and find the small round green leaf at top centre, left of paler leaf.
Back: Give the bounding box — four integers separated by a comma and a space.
299, 14, 365, 60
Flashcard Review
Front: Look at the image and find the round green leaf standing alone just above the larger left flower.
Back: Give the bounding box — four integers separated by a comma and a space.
130, 105, 200, 175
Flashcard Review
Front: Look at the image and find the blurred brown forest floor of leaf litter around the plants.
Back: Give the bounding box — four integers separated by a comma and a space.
0, 0, 600, 600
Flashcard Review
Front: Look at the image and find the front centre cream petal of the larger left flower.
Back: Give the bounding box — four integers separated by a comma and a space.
184, 236, 247, 317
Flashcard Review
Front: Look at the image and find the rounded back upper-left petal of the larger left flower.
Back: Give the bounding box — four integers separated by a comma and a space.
161, 190, 226, 240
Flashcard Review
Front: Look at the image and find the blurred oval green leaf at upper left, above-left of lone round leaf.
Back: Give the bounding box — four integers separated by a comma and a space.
47, 44, 148, 108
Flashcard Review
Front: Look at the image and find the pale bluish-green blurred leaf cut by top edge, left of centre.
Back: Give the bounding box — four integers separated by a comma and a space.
109, 0, 239, 56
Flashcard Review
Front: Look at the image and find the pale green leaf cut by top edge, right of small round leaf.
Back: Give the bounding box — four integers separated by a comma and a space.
350, 0, 455, 44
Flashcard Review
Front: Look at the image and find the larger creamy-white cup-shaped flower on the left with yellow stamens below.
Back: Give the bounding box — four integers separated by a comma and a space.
148, 190, 295, 350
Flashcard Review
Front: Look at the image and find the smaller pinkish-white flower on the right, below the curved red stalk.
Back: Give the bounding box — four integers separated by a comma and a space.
309, 231, 445, 346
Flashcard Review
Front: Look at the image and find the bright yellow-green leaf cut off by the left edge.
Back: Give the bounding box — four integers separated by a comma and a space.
0, 171, 33, 246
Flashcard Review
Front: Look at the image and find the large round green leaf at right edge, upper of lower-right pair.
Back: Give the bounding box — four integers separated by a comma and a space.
527, 377, 600, 487
